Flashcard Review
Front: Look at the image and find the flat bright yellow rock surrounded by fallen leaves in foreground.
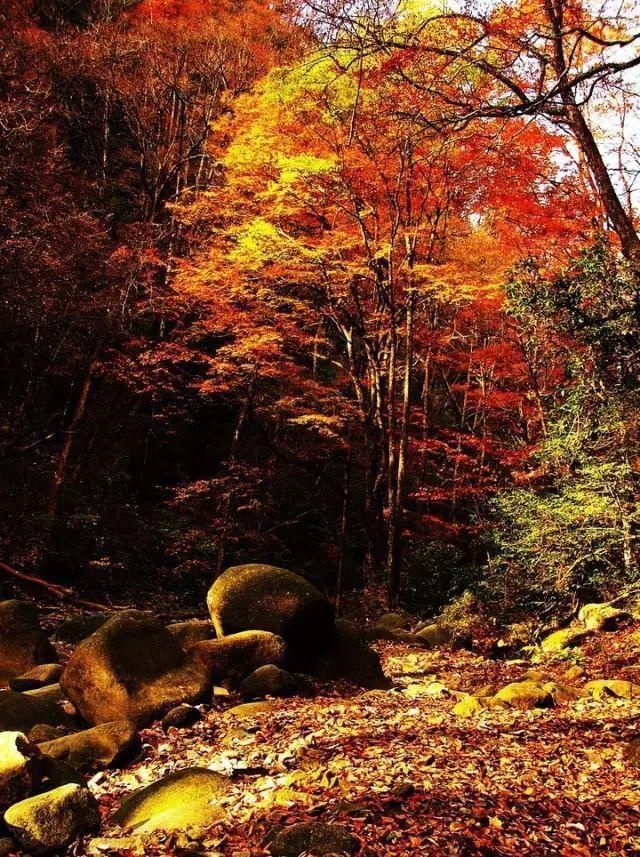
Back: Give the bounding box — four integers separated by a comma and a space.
112, 768, 230, 833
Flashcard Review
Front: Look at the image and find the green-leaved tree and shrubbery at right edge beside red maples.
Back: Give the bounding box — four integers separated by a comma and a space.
487, 243, 640, 611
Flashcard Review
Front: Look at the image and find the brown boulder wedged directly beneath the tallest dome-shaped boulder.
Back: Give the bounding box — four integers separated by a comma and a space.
190, 631, 287, 682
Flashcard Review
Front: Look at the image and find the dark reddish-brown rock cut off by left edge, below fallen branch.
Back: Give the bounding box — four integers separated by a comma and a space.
0, 600, 57, 684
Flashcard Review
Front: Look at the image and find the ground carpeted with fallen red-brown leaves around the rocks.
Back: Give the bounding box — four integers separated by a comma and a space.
81, 623, 640, 857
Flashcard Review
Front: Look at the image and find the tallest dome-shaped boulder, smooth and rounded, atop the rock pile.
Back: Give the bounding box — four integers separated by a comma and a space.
207, 564, 334, 660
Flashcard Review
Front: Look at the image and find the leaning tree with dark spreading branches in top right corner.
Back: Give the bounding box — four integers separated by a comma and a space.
309, 0, 640, 266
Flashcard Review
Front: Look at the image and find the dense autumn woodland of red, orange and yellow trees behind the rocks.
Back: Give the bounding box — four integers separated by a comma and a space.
0, 0, 640, 619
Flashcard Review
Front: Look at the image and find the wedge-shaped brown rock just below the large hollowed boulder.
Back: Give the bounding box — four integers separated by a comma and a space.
38, 720, 142, 770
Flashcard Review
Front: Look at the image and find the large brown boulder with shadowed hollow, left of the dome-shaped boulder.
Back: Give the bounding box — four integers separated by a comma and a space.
61, 616, 210, 725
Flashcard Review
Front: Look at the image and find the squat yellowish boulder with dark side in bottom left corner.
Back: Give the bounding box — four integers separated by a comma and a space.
4, 784, 100, 854
